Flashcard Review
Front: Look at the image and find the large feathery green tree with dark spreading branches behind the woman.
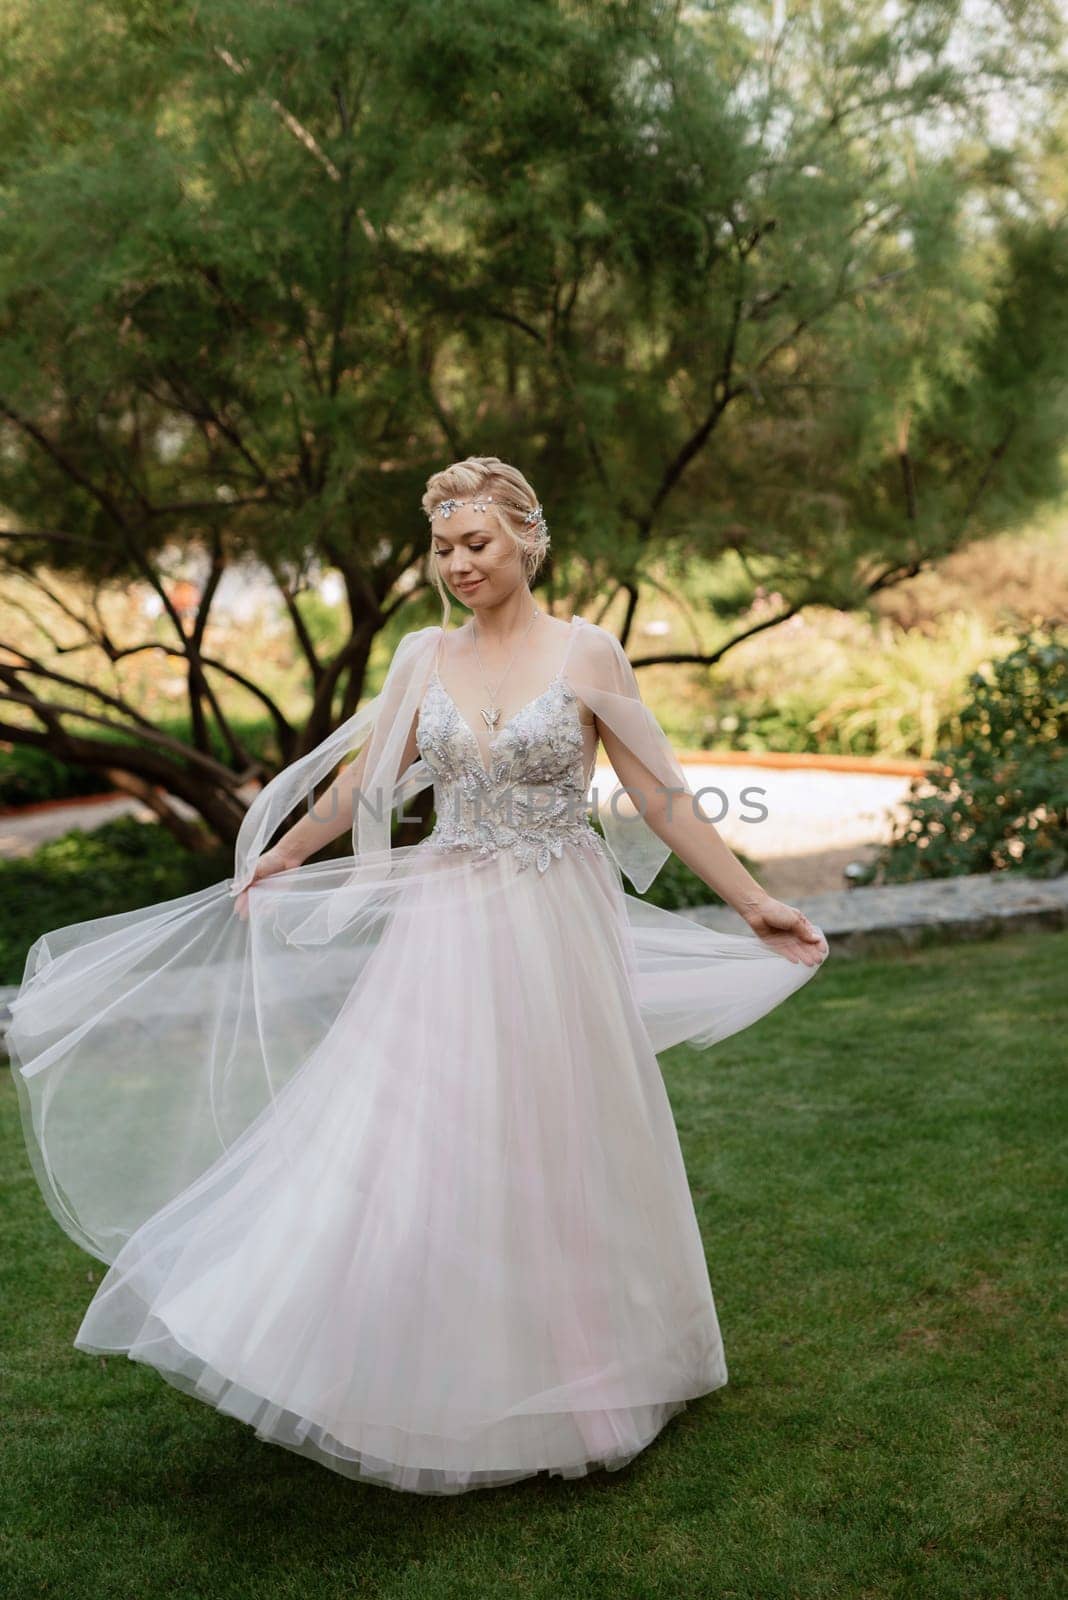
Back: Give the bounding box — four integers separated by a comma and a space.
0, 0, 1068, 840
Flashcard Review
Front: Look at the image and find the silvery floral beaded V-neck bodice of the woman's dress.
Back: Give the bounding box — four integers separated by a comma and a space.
416, 670, 604, 872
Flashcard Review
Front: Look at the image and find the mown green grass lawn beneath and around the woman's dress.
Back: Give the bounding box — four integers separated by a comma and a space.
0, 933, 1068, 1600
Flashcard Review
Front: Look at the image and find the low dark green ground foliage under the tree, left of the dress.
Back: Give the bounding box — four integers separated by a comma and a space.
0, 816, 233, 984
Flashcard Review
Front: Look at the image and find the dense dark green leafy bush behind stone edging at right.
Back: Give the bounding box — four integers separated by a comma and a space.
860, 626, 1068, 883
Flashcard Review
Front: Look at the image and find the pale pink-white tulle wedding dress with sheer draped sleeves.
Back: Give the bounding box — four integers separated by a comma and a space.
8, 604, 825, 1494
